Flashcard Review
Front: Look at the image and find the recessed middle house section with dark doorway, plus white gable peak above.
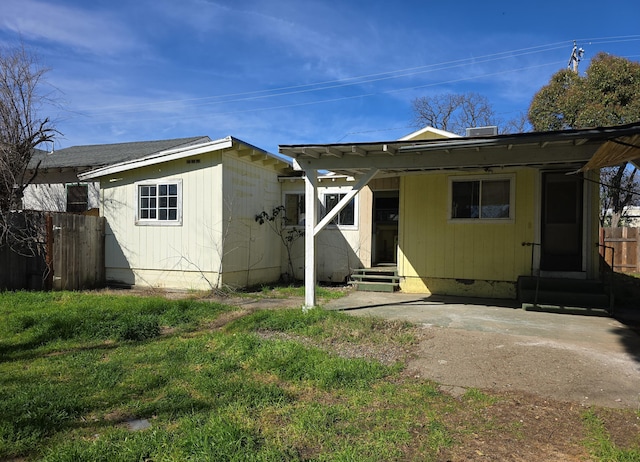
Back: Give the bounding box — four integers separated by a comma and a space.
281, 127, 459, 283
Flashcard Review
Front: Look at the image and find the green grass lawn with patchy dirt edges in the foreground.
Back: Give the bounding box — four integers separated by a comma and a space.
0, 292, 640, 462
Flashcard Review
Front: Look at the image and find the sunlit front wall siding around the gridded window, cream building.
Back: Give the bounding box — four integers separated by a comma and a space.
102, 153, 222, 289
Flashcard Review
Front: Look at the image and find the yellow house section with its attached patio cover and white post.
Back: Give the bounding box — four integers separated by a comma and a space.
279, 124, 640, 306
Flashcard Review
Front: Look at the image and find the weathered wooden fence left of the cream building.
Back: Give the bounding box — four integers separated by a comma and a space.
0, 212, 105, 290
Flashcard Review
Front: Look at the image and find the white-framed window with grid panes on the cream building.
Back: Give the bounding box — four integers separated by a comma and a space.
136, 181, 182, 224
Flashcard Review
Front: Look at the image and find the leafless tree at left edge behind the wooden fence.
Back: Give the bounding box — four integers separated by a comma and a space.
0, 46, 57, 252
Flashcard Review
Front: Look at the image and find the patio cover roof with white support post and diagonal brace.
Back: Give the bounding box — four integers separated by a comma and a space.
279, 123, 640, 308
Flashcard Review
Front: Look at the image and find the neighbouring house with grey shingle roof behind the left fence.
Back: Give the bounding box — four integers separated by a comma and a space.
22, 136, 211, 213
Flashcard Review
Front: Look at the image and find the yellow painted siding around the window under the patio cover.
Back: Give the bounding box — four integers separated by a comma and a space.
398, 169, 537, 296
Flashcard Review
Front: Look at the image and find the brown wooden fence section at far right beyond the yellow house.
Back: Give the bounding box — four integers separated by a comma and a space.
600, 227, 640, 273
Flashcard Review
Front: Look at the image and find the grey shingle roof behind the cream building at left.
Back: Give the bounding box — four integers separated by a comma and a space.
29, 136, 211, 170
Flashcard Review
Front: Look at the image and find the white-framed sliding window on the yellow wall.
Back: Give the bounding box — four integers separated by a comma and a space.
451, 177, 513, 220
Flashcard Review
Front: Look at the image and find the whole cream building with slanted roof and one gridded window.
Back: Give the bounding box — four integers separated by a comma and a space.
78, 136, 291, 290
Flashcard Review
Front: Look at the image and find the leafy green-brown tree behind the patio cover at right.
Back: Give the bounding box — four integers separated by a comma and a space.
528, 53, 640, 226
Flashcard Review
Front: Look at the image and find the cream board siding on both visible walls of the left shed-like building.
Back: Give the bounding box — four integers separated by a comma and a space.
103, 152, 280, 289
